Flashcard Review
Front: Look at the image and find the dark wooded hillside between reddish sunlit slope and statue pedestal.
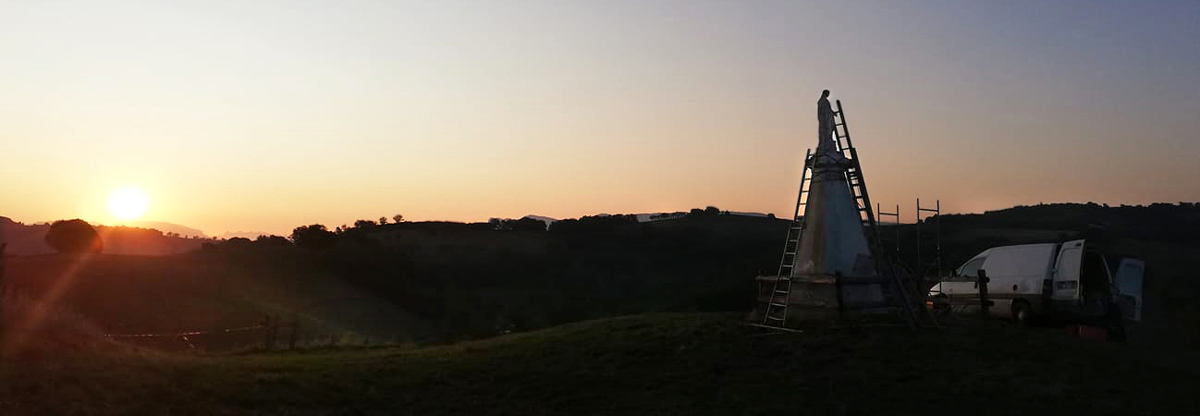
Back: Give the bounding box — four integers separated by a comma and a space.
338, 215, 787, 339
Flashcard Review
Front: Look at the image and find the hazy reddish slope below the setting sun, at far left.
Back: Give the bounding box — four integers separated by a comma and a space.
5, 248, 436, 349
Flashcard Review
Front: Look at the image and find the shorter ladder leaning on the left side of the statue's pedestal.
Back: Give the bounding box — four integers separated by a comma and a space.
762, 149, 814, 326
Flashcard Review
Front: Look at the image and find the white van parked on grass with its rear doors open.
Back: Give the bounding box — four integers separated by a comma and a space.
929, 240, 1145, 324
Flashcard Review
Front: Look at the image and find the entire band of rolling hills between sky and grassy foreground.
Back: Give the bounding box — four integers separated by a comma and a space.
2, 204, 1200, 350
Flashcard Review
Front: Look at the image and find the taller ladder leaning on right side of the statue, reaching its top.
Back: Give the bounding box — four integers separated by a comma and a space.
833, 100, 938, 328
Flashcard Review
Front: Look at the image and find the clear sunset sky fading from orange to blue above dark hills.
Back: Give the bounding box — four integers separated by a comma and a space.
0, 0, 1200, 235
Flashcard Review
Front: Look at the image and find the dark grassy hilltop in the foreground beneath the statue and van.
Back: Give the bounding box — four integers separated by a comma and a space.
0, 314, 1200, 415
